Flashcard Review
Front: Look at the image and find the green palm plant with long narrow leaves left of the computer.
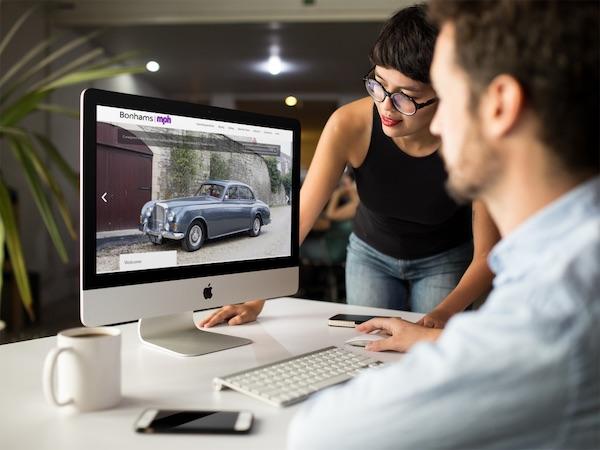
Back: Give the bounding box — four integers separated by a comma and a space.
0, 7, 144, 329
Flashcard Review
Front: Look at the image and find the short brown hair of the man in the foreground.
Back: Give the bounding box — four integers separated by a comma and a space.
428, 0, 600, 172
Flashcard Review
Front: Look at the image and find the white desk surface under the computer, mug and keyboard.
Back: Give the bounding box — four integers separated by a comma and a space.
0, 298, 421, 450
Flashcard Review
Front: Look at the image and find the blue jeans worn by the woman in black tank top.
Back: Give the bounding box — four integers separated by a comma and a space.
346, 233, 473, 313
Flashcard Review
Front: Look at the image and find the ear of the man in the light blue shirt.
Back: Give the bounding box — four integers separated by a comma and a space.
479, 75, 525, 139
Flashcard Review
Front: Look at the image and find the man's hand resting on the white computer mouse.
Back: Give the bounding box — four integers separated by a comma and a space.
356, 317, 441, 352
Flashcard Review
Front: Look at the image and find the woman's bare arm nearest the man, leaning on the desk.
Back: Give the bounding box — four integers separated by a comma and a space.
417, 201, 500, 328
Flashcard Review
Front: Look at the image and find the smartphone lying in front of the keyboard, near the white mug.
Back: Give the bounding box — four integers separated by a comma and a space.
135, 409, 253, 434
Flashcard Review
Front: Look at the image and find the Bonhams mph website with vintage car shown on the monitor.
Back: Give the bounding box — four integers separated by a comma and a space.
96, 106, 293, 273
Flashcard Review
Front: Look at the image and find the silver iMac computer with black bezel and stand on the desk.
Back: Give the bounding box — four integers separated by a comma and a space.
80, 89, 300, 356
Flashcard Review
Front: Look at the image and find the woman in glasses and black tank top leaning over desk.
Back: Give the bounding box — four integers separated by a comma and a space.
200, 5, 499, 334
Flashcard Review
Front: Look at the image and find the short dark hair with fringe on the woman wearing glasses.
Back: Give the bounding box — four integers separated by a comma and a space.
369, 4, 438, 84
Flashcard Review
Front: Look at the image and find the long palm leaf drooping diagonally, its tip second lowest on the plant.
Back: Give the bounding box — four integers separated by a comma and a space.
8, 138, 69, 262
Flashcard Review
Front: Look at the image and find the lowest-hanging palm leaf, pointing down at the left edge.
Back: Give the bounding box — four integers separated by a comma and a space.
0, 178, 35, 320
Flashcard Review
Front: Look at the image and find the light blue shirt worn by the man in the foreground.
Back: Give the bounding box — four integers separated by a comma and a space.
289, 177, 600, 450
